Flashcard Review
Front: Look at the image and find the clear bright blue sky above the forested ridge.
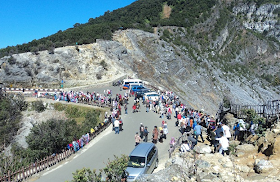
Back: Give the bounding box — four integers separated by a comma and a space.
0, 0, 136, 48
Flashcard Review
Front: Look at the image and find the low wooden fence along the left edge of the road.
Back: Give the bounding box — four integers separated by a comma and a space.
0, 122, 111, 182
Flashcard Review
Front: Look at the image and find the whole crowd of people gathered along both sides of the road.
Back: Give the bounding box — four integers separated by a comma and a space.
48, 80, 242, 154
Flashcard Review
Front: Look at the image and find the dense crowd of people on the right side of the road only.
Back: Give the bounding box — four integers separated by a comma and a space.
126, 87, 235, 155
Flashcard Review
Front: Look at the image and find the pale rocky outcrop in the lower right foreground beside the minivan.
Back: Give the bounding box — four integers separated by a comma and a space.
139, 119, 280, 182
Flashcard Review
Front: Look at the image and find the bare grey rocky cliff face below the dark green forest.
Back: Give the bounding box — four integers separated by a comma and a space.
0, 1, 280, 114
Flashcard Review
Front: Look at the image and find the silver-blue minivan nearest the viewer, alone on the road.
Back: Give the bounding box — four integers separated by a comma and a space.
126, 142, 158, 181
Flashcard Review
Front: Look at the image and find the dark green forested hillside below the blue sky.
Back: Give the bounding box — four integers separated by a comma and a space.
0, 0, 216, 57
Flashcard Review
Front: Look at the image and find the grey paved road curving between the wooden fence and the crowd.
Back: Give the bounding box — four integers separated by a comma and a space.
30, 86, 180, 182
